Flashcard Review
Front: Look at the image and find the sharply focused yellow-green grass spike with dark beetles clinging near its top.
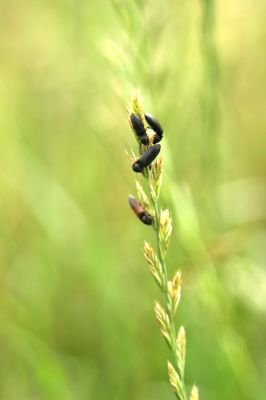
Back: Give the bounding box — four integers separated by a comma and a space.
128, 95, 199, 400
